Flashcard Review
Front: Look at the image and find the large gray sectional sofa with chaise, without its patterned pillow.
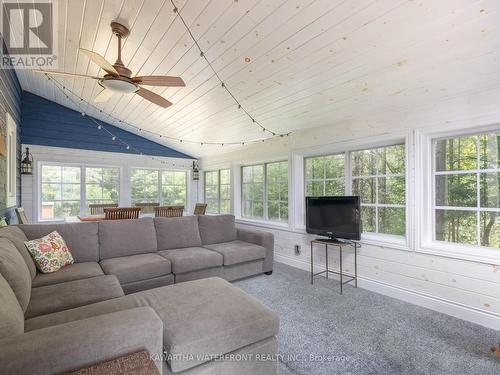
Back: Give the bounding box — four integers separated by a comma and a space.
0, 215, 279, 374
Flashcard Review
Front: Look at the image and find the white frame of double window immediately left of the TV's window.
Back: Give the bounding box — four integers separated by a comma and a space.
239, 158, 290, 226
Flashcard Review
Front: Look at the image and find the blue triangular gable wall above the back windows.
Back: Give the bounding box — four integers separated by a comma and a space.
21, 91, 193, 159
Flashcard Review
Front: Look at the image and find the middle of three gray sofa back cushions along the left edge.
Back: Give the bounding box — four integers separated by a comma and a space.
0, 238, 31, 311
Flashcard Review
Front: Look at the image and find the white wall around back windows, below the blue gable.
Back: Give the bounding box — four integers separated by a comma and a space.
21, 144, 198, 222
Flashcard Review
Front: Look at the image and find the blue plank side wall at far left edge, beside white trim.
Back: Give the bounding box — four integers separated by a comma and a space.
0, 68, 22, 224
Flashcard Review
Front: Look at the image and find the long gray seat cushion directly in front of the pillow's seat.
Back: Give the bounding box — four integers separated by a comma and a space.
25, 275, 124, 318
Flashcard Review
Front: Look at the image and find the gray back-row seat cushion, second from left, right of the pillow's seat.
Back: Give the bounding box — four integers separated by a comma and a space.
100, 254, 172, 284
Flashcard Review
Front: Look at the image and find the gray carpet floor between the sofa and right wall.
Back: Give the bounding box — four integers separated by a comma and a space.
235, 264, 500, 375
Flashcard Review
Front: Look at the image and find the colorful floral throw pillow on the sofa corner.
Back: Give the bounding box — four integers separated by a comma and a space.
24, 231, 75, 273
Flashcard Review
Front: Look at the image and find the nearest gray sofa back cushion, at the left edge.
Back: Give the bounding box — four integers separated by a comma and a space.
0, 275, 24, 339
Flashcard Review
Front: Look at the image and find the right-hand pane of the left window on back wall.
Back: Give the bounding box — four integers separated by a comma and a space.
85, 167, 120, 213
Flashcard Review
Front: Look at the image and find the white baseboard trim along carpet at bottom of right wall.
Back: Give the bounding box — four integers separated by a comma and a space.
274, 253, 500, 331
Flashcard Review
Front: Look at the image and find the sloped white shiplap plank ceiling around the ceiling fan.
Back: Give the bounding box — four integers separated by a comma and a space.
17, 0, 500, 156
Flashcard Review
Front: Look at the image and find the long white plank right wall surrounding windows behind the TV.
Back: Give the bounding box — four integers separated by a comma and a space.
197, 96, 500, 330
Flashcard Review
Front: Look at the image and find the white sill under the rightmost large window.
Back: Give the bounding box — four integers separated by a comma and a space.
415, 241, 500, 264
